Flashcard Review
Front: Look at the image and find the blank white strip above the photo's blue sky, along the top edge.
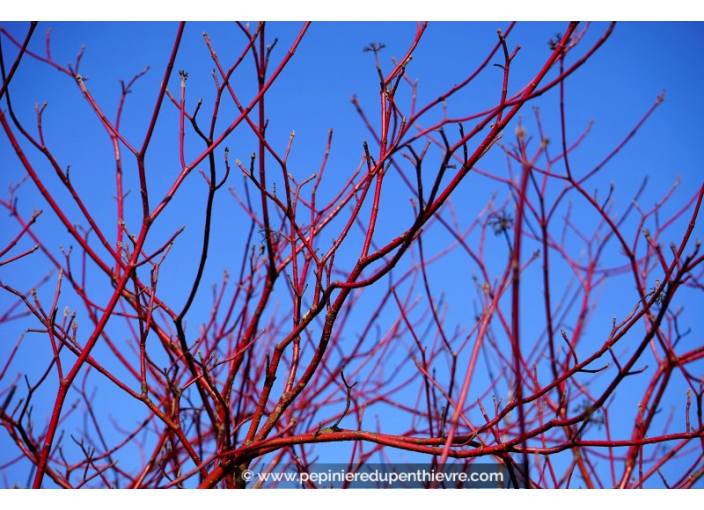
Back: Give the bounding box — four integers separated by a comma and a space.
0, 0, 704, 23
